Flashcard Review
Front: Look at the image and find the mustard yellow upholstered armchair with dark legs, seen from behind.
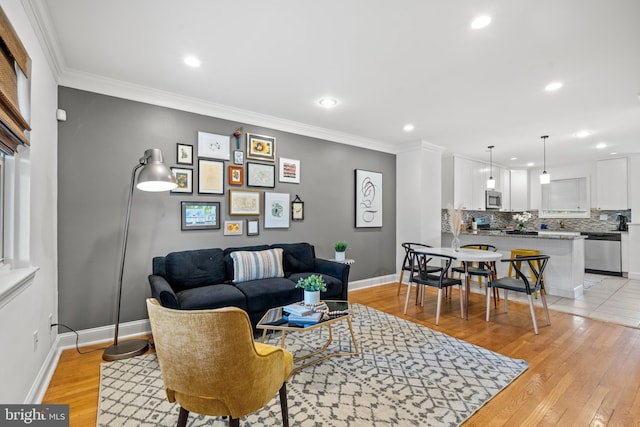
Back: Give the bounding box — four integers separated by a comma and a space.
147, 298, 293, 427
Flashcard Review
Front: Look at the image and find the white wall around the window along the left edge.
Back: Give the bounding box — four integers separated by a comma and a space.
0, 0, 58, 403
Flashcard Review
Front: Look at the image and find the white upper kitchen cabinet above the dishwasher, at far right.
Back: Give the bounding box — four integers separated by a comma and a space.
595, 158, 629, 210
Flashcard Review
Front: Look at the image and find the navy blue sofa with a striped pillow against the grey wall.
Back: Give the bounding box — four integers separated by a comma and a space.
149, 243, 349, 327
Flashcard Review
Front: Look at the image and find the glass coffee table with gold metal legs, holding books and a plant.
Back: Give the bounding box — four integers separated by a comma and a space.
256, 301, 360, 372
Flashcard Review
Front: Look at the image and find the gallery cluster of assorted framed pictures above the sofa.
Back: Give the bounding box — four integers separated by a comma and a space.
171, 128, 312, 236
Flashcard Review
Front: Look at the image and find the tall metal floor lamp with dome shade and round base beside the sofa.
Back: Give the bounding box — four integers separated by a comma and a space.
102, 148, 178, 361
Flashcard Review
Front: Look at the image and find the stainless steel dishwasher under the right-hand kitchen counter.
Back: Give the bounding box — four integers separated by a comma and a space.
580, 232, 622, 276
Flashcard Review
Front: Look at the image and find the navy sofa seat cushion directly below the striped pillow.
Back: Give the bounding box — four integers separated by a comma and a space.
236, 277, 302, 313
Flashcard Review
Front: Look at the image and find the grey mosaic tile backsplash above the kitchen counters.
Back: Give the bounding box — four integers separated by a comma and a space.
441, 209, 631, 232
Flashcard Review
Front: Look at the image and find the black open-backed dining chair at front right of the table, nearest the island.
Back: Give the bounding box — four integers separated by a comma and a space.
485, 255, 551, 335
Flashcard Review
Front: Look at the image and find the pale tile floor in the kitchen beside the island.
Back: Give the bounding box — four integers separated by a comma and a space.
472, 273, 640, 328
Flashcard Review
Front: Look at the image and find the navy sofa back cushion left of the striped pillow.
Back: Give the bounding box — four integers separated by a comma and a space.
165, 248, 227, 290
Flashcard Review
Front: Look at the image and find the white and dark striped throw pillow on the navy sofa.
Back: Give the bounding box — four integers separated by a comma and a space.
231, 248, 284, 283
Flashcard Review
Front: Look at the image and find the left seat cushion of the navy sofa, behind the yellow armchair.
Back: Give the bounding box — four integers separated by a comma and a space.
176, 284, 247, 310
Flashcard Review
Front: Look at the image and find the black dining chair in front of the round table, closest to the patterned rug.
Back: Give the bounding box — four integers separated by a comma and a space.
404, 249, 464, 325
